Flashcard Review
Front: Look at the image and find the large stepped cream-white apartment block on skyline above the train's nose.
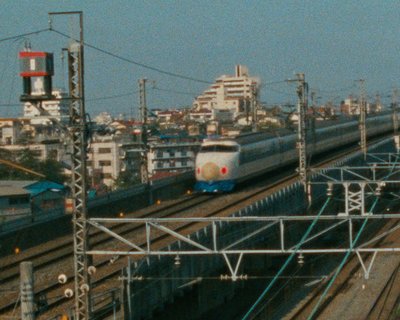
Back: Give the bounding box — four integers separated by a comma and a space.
193, 65, 260, 118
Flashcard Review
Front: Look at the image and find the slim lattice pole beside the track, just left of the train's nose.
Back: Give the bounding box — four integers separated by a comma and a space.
139, 78, 149, 184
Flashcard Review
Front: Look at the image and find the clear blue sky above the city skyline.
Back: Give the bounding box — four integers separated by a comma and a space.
0, 0, 400, 117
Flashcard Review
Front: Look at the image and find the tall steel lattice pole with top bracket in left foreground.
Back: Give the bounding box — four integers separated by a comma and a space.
49, 11, 91, 320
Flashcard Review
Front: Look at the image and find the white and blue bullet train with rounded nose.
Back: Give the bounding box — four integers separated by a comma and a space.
195, 114, 393, 193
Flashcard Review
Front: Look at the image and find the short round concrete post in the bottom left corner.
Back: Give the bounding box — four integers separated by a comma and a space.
20, 261, 35, 320
